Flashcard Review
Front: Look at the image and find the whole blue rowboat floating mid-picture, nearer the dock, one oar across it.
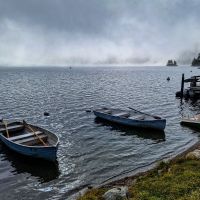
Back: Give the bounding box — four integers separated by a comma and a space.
93, 108, 166, 131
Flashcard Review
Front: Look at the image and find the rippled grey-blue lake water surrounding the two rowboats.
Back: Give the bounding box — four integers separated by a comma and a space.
0, 66, 200, 200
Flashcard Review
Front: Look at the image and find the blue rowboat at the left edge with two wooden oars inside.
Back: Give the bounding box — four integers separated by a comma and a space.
0, 121, 59, 161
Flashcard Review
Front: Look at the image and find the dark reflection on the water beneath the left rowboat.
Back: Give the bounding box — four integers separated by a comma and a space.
0, 145, 60, 183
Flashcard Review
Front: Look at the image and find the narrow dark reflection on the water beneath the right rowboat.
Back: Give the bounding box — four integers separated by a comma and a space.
95, 117, 165, 141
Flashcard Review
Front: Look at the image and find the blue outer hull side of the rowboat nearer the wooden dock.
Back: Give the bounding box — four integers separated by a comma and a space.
93, 111, 166, 131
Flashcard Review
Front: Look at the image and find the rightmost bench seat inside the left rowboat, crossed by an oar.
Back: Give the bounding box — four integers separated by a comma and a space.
15, 134, 48, 146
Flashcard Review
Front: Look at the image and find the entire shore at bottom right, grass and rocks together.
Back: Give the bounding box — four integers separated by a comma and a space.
78, 142, 200, 200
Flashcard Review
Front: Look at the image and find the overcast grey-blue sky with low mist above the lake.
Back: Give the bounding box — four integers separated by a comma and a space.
0, 0, 200, 65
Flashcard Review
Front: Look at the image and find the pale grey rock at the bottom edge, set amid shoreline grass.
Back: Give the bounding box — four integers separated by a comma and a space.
103, 187, 128, 200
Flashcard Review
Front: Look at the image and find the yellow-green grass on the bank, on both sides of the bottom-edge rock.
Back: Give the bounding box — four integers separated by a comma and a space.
79, 158, 200, 200
